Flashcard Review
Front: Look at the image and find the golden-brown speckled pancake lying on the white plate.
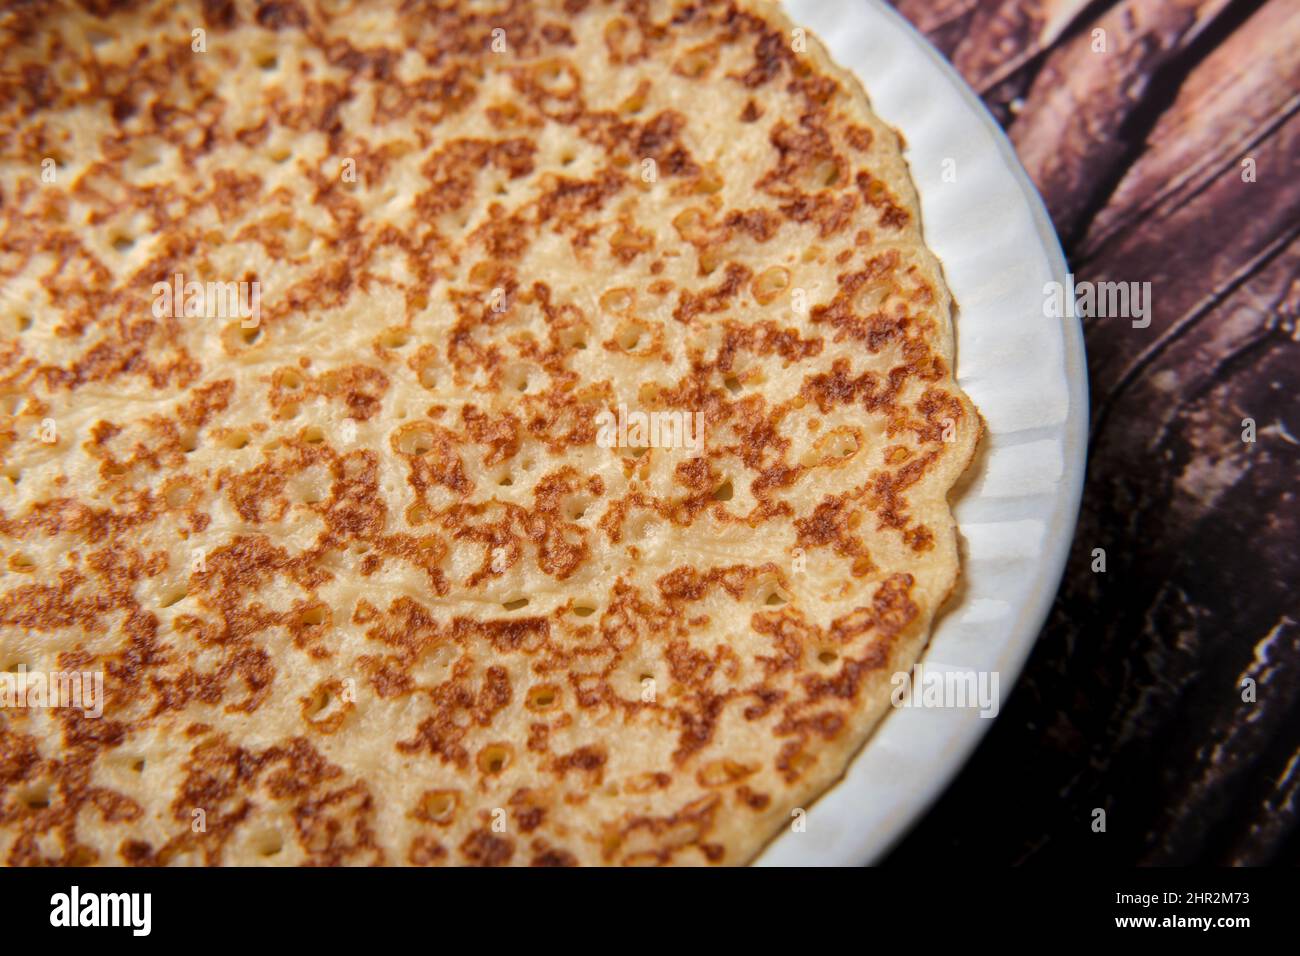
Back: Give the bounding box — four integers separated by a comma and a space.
0, 0, 982, 865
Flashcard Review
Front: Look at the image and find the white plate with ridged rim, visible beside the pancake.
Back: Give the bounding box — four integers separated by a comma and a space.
758, 0, 1088, 865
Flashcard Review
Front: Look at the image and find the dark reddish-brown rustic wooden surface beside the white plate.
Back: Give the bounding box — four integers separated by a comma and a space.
888, 0, 1300, 865
